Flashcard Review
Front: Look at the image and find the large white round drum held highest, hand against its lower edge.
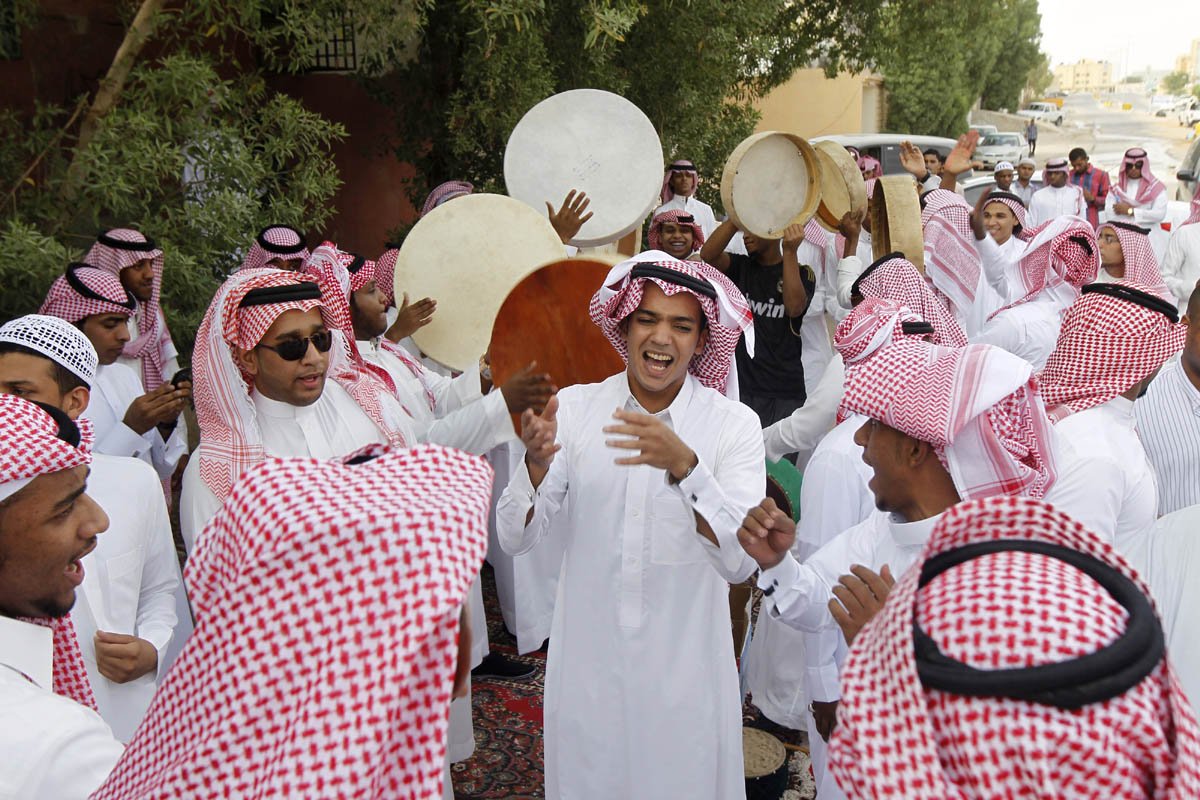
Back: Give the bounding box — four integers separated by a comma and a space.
504, 89, 662, 247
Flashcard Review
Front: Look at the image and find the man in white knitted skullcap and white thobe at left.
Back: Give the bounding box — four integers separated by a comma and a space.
0, 314, 182, 741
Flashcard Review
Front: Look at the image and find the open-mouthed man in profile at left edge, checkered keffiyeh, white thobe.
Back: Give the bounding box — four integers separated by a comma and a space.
0, 395, 124, 800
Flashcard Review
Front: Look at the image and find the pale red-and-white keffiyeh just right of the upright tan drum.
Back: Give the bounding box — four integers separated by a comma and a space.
920, 188, 983, 319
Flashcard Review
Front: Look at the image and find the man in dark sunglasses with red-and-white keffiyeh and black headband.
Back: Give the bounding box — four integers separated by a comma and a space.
180, 270, 416, 551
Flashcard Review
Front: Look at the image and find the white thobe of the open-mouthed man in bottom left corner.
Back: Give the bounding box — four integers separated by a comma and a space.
0, 616, 125, 800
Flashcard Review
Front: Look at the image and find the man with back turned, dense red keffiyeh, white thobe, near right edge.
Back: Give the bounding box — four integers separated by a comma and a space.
1038, 283, 1184, 558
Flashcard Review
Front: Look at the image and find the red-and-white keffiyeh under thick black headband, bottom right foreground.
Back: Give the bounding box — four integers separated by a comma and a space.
829, 498, 1200, 800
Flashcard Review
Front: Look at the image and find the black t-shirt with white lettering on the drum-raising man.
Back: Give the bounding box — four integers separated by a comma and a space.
726, 253, 816, 402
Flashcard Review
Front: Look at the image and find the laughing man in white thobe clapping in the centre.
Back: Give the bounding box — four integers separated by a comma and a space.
497, 256, 766, 800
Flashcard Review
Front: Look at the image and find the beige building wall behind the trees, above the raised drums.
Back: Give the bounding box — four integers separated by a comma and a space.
755, 68, 886, 139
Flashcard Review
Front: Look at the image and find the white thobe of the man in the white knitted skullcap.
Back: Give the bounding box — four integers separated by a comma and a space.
71, 453, 182, 741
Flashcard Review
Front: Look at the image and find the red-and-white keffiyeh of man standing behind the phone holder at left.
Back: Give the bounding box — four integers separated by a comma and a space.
83, 228, 170, 392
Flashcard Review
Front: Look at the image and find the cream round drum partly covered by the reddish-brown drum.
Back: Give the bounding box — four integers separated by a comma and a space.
396, 194, 563, 371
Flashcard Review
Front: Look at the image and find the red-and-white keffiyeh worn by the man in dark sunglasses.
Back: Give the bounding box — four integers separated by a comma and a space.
192, 270, 404, 498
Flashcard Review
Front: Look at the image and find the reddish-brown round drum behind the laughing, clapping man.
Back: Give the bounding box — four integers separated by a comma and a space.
487, 258, 625, 398
